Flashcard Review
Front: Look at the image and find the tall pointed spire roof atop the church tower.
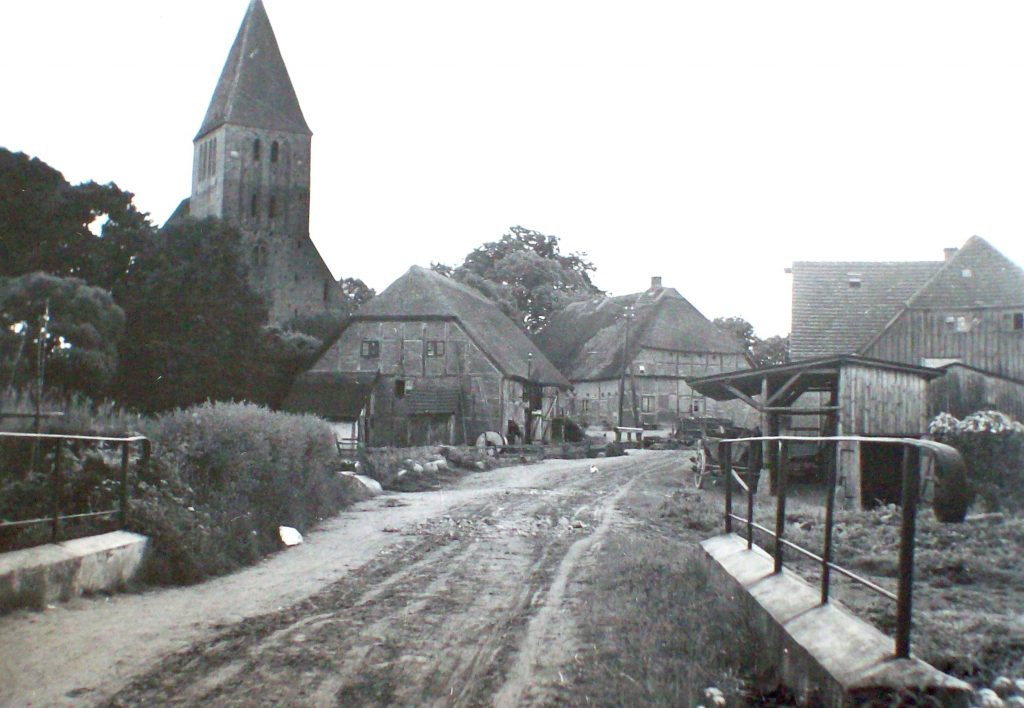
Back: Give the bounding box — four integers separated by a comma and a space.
196, 0, 312, 139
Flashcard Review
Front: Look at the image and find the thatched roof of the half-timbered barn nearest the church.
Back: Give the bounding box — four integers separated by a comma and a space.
342, 265, 569, 387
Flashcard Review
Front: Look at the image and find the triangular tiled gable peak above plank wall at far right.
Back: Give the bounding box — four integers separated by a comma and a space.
907, 236, 1024, 307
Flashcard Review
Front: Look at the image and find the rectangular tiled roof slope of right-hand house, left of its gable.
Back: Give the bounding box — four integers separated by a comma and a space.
790, 260, 942, 361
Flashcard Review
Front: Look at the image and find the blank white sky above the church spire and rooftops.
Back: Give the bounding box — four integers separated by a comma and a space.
6, 0, 1024, 337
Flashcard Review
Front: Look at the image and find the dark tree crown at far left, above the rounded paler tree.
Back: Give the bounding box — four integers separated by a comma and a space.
0, 149, 154, 290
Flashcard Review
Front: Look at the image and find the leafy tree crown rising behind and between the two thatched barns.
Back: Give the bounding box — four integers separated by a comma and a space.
431, 226, 602, 332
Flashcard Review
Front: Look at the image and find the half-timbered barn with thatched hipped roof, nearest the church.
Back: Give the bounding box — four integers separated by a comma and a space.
293, 265, 569, 446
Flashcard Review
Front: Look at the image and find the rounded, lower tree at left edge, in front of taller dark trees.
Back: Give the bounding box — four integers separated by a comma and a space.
0, 273, 125, 398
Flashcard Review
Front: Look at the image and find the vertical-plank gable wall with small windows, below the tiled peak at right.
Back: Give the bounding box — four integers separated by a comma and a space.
863, 308, 1024, 379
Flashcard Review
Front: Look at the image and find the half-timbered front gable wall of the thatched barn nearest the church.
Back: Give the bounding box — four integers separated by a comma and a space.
315, 321, 506, 445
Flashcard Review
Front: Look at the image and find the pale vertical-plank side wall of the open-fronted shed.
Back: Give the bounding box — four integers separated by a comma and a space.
839, 366, 928, 435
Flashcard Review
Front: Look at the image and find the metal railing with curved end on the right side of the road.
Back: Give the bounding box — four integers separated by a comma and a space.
718, 435, 963, 659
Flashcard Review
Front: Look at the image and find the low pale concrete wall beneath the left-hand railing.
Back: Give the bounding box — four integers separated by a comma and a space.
0, 531, 147, 612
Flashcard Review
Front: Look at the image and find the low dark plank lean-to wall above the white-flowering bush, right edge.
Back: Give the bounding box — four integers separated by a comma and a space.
928, 366, 1024, 420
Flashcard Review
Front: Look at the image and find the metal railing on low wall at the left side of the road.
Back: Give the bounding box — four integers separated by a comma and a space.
0, 432, 152, 542
